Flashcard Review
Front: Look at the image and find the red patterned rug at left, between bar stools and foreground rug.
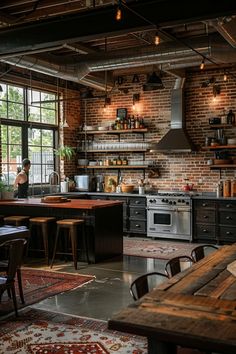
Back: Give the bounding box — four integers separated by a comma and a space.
0, 268, 94, 316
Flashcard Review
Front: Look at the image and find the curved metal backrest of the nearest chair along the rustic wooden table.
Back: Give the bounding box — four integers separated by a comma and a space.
130, 272, 168, 301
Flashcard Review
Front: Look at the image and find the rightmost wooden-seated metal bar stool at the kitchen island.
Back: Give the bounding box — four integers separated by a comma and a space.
51, 219, 89, 269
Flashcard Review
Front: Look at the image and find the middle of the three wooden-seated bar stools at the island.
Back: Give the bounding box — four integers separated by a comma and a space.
27, 216, 56, 265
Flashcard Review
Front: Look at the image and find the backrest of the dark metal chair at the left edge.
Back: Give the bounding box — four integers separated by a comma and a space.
1, 238, 27, 281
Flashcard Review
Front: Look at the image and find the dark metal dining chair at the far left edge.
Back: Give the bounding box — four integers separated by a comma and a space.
0, 238, 27, 316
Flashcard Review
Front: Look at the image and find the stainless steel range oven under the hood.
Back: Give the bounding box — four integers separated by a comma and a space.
147, 194, 192, 241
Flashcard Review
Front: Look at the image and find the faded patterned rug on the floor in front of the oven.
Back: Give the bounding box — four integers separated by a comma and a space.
123, 237, 200, 259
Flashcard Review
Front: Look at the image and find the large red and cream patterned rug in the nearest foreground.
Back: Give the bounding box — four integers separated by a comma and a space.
0, 308, 206, 354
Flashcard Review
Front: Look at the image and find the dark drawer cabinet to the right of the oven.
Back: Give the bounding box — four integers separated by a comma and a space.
193, 199, 236, 244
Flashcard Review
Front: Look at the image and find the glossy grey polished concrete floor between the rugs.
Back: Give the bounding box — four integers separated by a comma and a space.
26, 252, 166, 320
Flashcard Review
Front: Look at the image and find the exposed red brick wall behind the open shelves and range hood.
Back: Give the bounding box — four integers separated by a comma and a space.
64, 70, 236, 191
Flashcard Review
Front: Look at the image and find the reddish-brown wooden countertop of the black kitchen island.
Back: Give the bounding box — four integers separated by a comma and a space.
0, 198, 122, 210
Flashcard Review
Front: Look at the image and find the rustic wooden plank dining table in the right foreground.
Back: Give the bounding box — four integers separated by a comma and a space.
108, 243, 236, 354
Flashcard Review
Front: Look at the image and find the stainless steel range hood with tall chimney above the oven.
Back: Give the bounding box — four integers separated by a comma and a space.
152, 78, 195, 153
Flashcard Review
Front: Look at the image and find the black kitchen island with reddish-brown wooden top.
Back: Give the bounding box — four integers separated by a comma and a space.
0, 198, 123, 263
